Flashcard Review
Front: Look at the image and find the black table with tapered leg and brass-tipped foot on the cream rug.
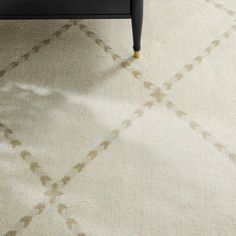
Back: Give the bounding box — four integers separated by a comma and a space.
0, 0, 143, 57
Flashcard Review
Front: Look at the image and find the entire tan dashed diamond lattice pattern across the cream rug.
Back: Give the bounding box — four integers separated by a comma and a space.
3, 0, 236, 232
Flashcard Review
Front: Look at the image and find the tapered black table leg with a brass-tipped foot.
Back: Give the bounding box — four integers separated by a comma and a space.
131, 0, 143, 58
